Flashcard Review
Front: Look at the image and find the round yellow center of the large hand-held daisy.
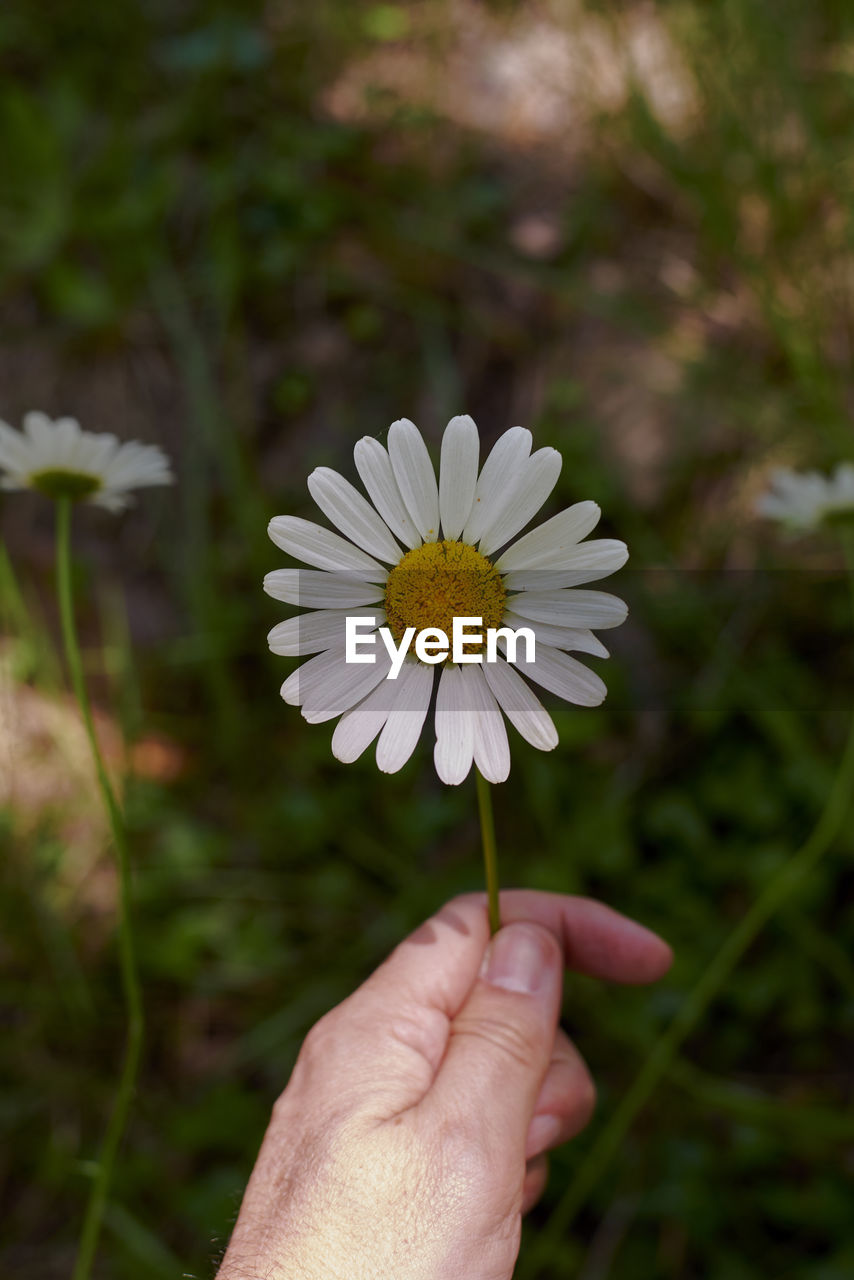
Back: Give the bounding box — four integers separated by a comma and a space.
385, 541, 507, 653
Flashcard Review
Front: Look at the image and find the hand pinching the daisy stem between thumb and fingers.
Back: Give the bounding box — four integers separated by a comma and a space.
219, 890, 671, 1280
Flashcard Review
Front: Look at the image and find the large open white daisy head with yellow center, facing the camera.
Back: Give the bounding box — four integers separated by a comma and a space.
264, 416, 629, 783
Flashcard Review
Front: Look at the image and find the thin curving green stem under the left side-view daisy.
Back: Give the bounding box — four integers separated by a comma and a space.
56, 498, 143, 1280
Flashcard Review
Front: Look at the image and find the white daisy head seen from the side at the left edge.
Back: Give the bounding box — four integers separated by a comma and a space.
0, 413, 174, 512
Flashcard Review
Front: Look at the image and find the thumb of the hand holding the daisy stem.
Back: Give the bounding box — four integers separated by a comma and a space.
431, 923, 563, 1158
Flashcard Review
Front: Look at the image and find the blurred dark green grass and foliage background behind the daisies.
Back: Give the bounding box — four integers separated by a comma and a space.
0, 0, 854, 1280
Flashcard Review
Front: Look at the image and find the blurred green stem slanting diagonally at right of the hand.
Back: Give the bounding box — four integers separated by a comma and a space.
526, 536, 854, 1276
